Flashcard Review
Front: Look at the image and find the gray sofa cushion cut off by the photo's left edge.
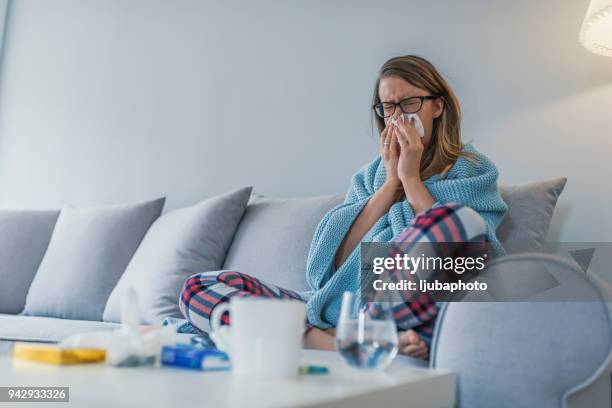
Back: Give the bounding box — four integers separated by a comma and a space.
0, 210, 59, 313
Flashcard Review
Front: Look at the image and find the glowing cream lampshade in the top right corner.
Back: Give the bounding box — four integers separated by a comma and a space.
579, 0, 612, 57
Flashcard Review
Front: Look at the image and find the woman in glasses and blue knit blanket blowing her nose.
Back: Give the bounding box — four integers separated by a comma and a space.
179, 55, 507, 359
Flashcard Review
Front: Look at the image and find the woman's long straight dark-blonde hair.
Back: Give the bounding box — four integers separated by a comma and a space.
372, 55, 472, 180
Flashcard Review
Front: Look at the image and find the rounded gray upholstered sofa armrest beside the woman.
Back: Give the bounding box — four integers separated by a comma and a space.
430, 254, 612, 408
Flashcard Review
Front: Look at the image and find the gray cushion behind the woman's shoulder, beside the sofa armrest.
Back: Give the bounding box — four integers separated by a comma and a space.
497, 178, 567, 253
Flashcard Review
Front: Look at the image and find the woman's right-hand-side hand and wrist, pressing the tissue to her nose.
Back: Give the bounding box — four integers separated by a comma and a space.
392, 116, 424, 185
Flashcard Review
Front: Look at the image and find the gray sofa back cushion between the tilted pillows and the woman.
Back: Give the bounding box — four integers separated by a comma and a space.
223, 194, 344, 291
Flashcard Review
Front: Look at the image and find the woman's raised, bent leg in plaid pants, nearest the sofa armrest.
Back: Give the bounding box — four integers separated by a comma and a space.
393, 203, 487, 345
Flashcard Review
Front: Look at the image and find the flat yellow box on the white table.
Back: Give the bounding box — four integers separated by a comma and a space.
13, 343, 106, 365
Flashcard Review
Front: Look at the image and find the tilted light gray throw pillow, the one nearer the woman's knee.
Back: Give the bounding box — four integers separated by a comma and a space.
103, 187, 251, 324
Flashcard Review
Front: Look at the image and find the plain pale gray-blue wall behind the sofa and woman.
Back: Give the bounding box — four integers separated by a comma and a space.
0, 0, 612, 241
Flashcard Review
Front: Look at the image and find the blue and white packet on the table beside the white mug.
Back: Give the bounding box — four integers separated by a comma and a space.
161, 344, 230, 371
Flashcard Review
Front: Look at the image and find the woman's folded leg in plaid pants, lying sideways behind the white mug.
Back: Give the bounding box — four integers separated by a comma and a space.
179, 271, 304, 333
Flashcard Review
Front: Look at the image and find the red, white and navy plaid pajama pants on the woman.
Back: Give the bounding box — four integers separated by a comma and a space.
179, 203, 487, 342
